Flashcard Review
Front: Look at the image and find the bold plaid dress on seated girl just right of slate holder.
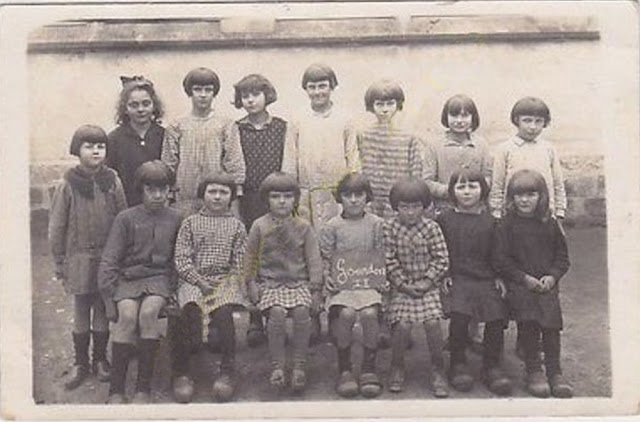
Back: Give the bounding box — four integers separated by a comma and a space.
383, 217, 449, 324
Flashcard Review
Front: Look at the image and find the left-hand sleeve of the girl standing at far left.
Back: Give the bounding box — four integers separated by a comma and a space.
48, 182, 71, 271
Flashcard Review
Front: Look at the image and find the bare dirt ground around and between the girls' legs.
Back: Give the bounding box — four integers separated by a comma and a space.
31, 228, 611, 404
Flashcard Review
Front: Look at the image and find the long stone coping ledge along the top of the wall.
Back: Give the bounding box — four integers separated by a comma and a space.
28, 15, 600, 54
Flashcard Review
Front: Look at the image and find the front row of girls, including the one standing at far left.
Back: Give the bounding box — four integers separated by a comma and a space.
55, 127, 573, 403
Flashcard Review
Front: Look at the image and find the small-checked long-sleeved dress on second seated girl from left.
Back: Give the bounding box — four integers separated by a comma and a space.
175, 210, 247, 314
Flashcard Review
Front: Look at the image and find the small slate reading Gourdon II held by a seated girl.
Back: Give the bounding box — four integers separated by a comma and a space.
331, 251, 386, 290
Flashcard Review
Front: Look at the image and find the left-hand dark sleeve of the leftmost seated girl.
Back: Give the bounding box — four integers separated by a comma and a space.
98, 213, 127, 297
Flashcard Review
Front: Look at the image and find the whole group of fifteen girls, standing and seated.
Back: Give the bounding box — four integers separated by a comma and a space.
49, 64, 573, 403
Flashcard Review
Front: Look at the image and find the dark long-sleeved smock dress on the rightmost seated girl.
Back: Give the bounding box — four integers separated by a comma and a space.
495, 214, 569, 330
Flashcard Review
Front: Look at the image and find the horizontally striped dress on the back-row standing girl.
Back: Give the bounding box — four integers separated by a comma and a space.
346, 123, 423, 218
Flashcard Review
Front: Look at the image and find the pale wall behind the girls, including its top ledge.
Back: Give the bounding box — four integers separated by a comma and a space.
28, 14, 606, 234
